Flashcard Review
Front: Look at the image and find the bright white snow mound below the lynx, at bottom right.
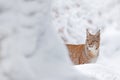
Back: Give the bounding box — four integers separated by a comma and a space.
75, 63, 120, 80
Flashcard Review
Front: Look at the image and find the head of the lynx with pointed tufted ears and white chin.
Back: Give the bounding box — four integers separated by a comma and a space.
86, 29, 100, 54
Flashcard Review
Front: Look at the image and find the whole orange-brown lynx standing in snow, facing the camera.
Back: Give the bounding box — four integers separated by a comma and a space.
66, 29, 100, 65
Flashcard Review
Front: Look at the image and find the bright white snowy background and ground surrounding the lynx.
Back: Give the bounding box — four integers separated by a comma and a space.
52, 0, 120, 80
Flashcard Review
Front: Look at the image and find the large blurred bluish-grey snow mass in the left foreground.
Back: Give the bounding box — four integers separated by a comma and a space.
0, 0, 96, 80
